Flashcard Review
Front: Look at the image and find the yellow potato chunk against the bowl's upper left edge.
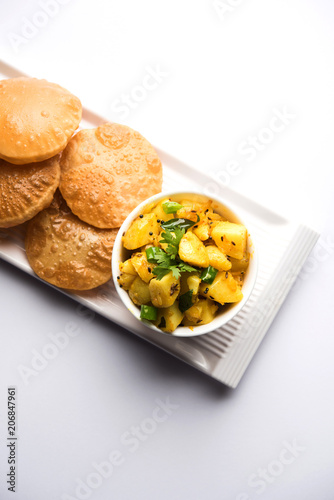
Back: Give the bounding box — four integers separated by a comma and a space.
123, 213, 160, 250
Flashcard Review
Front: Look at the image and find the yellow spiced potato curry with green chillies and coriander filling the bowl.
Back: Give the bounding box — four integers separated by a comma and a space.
117, 198, 249, 333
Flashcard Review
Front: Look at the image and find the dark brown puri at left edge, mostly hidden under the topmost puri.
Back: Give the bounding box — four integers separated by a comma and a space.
0, 155, 60, 227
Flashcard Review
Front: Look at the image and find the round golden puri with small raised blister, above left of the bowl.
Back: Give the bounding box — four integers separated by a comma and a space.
60, 123, 162, 228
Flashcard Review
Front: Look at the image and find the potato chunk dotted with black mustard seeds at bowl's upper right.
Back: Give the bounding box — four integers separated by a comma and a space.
211, 221, 247, 259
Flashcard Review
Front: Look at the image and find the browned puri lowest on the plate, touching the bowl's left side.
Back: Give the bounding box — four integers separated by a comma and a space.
25, 191, 117, 290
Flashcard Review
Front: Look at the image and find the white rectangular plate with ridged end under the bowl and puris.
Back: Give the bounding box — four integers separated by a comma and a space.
0, 62, 319, 387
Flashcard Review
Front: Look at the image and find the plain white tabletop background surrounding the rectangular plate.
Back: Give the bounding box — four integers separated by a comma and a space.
0, 0, 334, 500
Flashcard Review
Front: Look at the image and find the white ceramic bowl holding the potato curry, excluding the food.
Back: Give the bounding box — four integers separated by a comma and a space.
112, 191, 257, 337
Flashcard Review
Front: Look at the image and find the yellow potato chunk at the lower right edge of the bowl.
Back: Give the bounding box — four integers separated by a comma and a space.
199, 271, 243, 305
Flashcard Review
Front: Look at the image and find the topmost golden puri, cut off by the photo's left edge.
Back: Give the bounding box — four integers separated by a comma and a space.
0, 77, 82, 165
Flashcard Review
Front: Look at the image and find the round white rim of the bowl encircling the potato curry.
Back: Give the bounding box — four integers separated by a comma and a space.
111, 189, 258, 337
